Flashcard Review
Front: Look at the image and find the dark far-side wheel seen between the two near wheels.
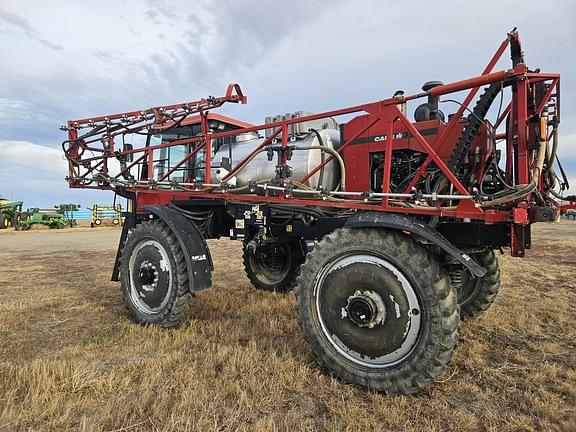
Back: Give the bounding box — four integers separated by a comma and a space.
242, 241, 304, 293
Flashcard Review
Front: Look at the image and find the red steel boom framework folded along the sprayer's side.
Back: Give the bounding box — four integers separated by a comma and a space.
64, 32, 560, 236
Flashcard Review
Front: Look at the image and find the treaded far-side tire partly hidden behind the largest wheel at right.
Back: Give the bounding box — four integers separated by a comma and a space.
450, 250, 500, 320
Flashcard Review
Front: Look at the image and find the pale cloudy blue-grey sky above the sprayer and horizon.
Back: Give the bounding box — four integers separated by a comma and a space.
0, 0, 576, 207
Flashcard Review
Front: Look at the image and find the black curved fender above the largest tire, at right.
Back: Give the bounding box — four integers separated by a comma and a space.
344, 212, 487, 277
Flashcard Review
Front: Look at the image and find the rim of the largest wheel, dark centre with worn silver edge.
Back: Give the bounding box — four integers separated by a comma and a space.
313, 254, 423, 368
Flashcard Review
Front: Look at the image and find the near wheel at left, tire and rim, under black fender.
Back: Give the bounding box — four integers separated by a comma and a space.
120, 221, 193, 328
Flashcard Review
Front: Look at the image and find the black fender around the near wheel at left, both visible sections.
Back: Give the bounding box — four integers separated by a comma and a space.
112, 205, 214, 292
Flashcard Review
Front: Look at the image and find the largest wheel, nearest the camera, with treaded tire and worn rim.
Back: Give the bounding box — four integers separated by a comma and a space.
296, 228, 459, 394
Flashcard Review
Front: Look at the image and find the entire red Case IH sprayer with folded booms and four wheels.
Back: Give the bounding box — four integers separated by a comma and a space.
63, 31, 576, 393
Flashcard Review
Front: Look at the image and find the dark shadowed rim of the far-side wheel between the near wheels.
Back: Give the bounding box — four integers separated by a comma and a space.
249, 243, 292, 285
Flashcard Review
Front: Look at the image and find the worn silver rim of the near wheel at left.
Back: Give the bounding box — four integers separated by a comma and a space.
128, 239, 173, 314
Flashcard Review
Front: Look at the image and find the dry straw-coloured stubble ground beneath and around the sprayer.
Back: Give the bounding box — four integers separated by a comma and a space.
0, 222, 576, 431
